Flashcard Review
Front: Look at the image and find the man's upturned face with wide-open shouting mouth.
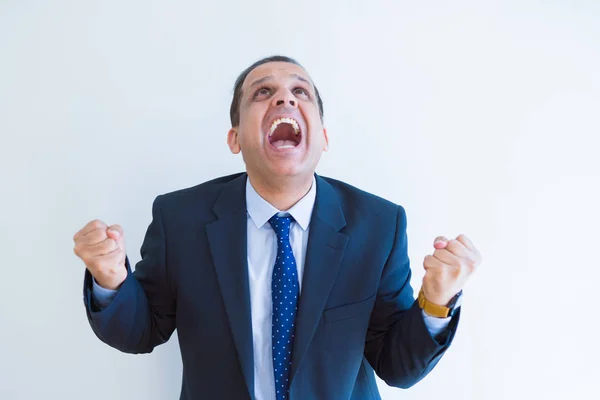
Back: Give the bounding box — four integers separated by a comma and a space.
227, 62, 328, 180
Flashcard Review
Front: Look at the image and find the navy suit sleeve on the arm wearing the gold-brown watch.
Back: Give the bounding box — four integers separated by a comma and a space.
365, 206, 460, 388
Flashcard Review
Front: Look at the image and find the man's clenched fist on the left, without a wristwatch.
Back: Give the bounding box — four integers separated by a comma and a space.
73, 220, 127, 290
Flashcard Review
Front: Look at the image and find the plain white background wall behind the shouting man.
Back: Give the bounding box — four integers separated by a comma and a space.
0, 0, 600, 400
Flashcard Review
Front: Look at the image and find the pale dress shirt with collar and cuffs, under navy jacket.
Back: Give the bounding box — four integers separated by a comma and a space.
93, 178, 450, 400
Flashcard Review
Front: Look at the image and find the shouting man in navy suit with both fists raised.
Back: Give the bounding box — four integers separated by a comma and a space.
74, 56, 481, 400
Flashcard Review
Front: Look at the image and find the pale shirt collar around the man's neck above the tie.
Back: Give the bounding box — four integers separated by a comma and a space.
246, 175, 317, 230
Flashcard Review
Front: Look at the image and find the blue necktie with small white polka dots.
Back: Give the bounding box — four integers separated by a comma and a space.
269, 215, 299, 400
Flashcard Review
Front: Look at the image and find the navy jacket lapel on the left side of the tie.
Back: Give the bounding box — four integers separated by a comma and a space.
206, 174, 254, 399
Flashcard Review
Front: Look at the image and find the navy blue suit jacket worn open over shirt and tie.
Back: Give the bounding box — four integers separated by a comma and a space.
84, 173, 459, 400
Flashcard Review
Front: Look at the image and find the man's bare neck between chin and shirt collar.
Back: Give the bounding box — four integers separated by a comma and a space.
248, 172, 313, 211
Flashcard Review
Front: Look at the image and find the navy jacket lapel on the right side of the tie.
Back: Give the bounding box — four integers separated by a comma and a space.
290, 176, 348, 383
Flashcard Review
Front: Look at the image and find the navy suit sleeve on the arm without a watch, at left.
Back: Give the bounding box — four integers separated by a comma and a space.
83, 196, 176, 353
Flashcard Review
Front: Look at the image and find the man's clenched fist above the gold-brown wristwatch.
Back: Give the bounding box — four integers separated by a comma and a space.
423, 235, 481, 306
